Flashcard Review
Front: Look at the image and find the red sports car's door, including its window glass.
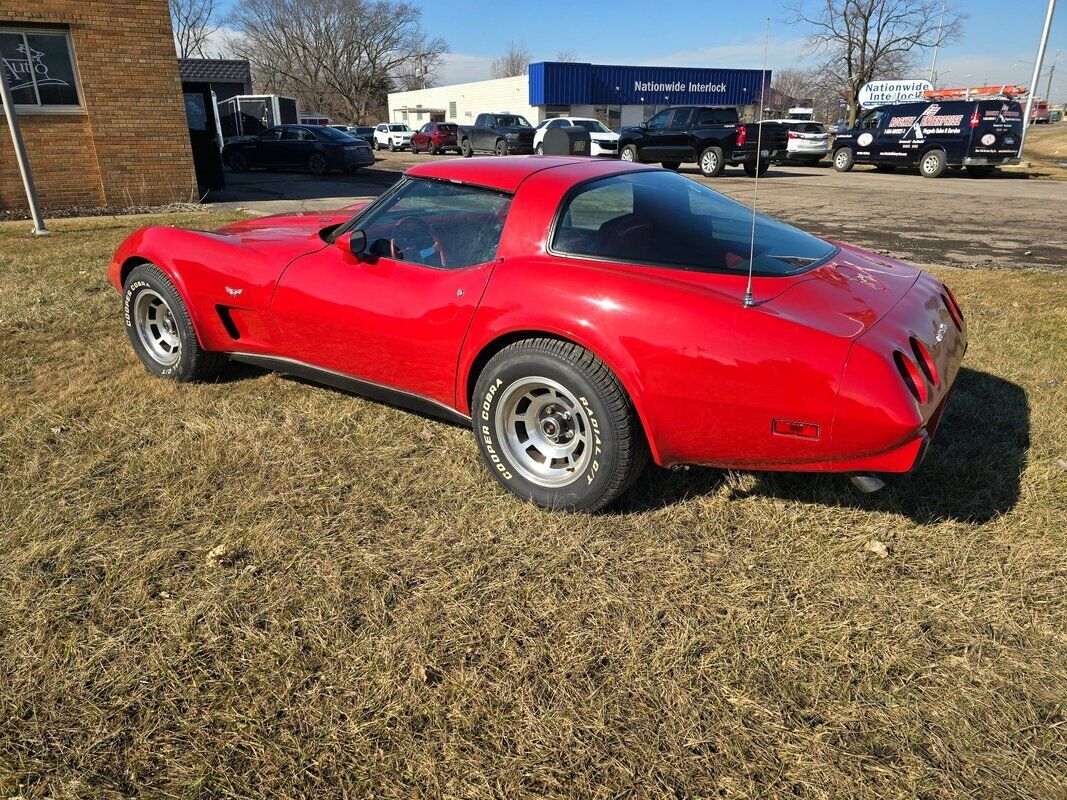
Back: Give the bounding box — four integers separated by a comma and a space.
271, 178, 511, 405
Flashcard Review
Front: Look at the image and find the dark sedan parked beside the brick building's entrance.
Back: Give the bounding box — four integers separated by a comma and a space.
222, 125, 375, 175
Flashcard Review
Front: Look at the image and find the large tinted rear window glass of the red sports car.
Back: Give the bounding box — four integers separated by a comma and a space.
552, 170, 837, 275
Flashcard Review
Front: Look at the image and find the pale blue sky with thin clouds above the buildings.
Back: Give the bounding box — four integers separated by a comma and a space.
212, 0, 1067, 102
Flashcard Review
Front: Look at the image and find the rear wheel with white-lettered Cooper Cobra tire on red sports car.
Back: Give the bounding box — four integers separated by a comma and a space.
472, 338, 648, 512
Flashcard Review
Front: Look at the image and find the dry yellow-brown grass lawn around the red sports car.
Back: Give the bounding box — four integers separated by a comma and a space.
0, 214, 1067, 800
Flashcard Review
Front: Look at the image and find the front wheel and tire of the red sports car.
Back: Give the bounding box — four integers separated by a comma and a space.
123, 263, 226, 381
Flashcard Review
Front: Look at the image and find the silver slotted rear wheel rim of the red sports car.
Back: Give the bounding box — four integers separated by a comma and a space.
494, 378, 594, 487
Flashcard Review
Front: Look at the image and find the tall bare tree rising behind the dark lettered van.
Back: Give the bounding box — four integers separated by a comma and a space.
789, 0, 965, 123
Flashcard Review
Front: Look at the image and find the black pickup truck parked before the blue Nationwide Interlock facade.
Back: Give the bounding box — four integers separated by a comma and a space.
619, 106, 789, 178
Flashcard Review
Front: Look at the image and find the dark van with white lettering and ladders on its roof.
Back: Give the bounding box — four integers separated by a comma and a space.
833, 99, 1022, 178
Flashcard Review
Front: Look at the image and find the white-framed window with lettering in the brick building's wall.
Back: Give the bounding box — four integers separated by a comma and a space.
0, 28, 81, 110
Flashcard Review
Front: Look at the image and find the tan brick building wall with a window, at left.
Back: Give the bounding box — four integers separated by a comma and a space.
0, 0, 196, 209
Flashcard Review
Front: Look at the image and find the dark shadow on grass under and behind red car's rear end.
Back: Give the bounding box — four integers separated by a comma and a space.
614, 368, 1030, 524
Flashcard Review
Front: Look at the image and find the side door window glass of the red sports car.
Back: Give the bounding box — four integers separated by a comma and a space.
360, 178, 511, 269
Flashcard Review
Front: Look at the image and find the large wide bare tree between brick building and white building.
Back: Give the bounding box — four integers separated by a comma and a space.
227, 0, 447, 123
